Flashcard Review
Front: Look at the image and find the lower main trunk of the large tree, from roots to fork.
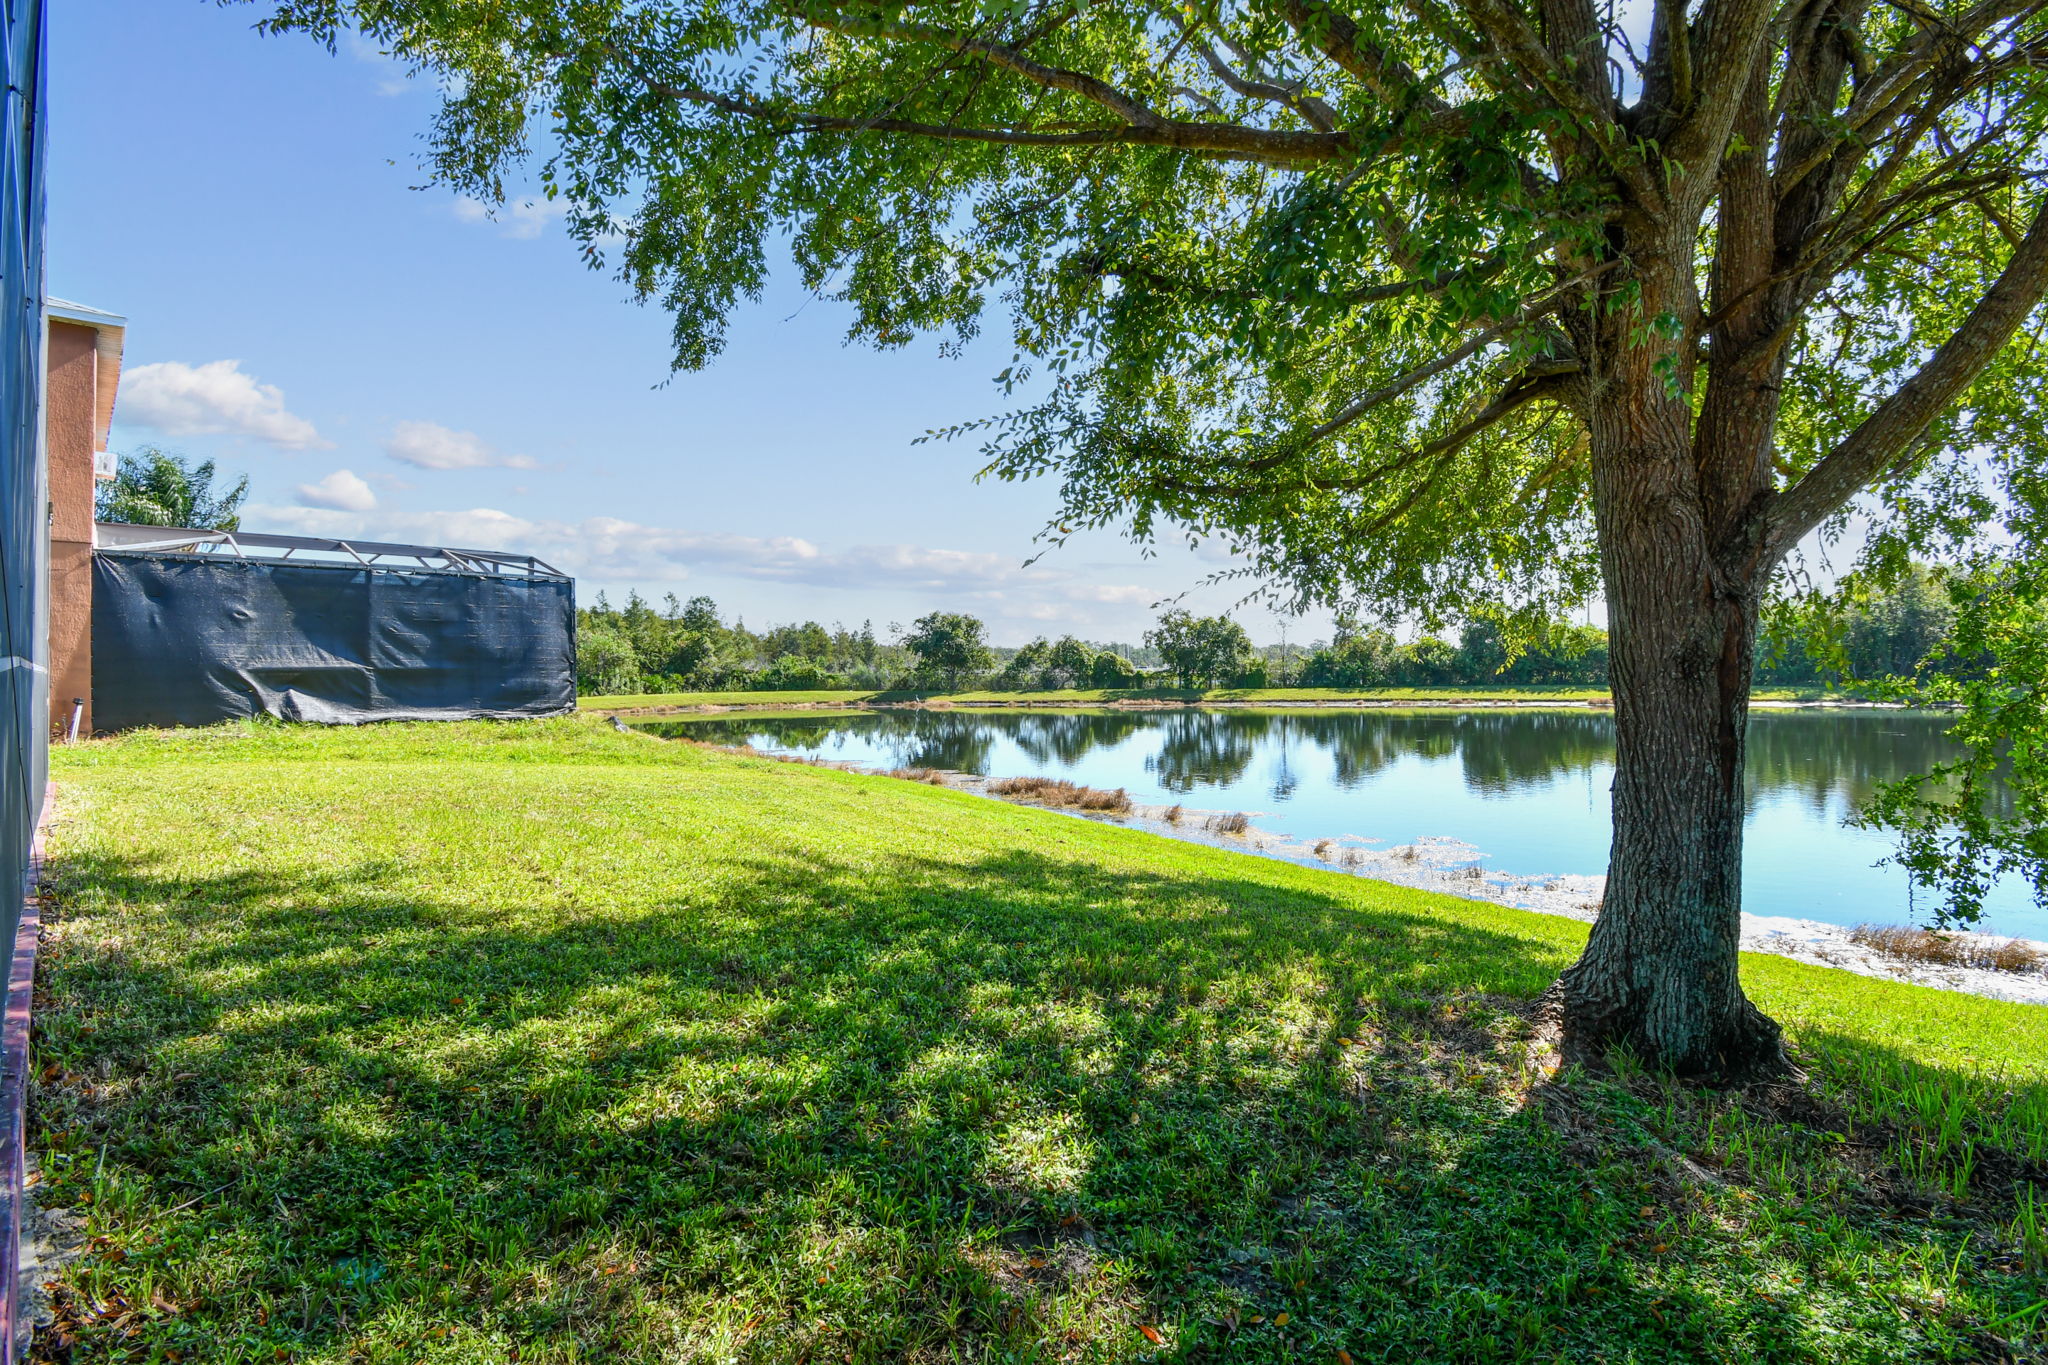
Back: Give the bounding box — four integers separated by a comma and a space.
1556, 401, 1786, 1081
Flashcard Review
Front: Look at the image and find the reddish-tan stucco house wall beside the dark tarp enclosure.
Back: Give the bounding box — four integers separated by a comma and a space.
43, 319, 98, 735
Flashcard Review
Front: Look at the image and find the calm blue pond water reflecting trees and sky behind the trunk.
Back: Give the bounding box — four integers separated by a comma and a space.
641, 708, 2048, 939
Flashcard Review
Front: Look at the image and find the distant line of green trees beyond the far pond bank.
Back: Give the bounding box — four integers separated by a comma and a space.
578, 571, 1970, 694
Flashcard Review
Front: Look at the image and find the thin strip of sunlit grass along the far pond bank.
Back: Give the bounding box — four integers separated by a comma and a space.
575, 688, 1829, 710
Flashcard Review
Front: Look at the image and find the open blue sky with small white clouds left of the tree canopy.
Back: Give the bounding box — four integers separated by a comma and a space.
49, 0, 1327, 645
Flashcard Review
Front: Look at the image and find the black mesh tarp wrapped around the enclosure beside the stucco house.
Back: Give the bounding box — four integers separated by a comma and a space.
92, 551, 575, 731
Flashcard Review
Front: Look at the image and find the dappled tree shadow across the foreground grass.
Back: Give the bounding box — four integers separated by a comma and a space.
37, 847, 2030, 1361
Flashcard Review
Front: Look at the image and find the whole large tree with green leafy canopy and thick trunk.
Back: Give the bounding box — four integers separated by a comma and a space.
266, 0, 2048, 1076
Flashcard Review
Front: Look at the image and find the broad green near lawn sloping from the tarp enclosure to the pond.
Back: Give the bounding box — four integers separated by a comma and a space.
31, 718, 2048, 1365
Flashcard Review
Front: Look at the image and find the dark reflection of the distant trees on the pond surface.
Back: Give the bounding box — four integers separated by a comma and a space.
643, 710, 1998, 817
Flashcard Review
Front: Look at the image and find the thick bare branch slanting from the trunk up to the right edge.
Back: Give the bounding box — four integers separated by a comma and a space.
1763, 205, 2048, 561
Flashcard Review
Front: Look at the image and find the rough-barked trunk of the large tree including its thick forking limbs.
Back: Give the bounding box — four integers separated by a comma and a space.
1554, 200, 2048, 1083
